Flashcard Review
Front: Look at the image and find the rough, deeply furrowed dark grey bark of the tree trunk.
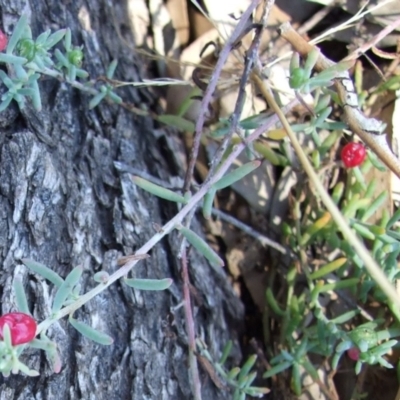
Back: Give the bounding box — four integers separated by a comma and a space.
0, 0, 243, 400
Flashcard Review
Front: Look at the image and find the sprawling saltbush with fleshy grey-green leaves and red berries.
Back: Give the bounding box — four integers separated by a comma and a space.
0, 10, 400, 399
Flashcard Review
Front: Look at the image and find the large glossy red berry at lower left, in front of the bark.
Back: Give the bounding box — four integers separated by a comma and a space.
0, 312, 37, 346
